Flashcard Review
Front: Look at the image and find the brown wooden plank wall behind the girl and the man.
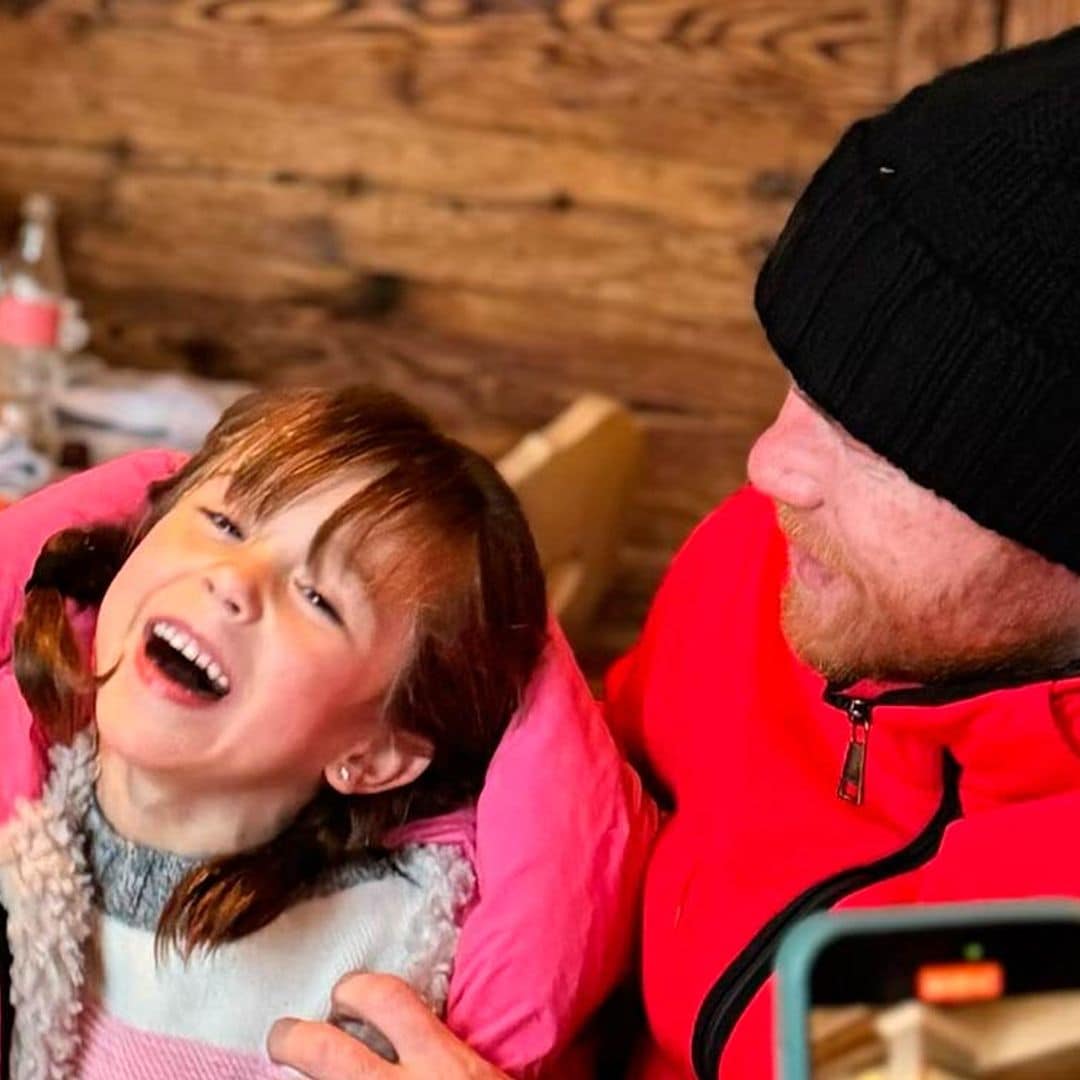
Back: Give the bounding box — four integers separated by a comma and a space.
0, 0, 1080, 656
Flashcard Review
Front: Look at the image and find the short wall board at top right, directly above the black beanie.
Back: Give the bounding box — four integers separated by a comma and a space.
892, 0, 1003, 97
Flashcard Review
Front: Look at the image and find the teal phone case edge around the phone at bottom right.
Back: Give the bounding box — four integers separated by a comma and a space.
773, 900, 1080, 1080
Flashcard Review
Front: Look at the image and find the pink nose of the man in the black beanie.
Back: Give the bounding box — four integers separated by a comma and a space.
746, 389, 836, 510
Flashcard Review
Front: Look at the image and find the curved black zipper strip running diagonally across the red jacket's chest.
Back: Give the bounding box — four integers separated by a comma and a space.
691, 753, 960, 1080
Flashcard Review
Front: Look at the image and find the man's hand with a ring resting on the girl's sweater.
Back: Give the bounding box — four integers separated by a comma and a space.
267, 974, 508, 1080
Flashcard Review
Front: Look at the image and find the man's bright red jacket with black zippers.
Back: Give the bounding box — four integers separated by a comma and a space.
608, 489, 1080, 1080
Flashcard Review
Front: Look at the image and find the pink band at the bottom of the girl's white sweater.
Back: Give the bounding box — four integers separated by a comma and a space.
75, 1001, 287, 1080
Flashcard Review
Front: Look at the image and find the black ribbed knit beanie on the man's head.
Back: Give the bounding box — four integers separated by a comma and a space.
755, 29, 1080, 572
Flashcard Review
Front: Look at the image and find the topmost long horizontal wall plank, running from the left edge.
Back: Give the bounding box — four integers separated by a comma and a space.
0, 0, 885, 181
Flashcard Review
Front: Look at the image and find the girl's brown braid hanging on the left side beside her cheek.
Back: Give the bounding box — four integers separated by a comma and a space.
14, 525, 131, 743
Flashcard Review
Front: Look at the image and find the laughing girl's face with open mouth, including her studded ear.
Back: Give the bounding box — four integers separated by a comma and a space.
94, 476, 427, 813
